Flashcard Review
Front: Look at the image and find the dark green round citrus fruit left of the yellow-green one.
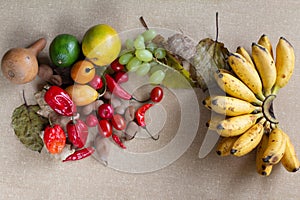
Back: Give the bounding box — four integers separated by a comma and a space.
49, 34, 81, 67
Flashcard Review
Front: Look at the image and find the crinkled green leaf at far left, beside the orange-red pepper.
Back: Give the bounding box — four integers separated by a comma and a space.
12, 104, 48, 152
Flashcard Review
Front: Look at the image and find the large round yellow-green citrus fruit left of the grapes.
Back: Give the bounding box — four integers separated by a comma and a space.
82, 24, 121, 66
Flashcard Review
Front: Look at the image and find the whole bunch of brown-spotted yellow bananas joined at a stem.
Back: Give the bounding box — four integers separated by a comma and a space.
203, 35, 300, 176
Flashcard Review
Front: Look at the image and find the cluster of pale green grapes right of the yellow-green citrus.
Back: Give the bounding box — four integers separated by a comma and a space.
119, 29, 166, 84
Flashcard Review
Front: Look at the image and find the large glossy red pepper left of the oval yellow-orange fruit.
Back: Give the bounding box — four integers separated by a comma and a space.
44, 86, 76, 116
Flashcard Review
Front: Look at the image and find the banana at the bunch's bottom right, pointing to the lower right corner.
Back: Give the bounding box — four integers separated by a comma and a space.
281, 134, 300, 172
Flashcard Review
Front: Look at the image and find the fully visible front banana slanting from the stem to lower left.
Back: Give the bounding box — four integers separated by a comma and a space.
230, 118, 266, 157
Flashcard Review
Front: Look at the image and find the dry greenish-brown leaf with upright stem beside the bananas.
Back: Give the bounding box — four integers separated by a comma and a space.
190, 38, 230, 90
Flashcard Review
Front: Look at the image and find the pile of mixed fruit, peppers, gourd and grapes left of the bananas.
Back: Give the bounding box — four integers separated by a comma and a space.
2, 24, 166, 163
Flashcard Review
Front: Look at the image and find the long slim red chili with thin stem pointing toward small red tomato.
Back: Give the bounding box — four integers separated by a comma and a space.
105, 74, 149, 103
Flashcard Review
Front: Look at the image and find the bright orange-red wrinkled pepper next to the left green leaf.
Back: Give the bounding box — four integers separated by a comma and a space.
43, 124, 66, 154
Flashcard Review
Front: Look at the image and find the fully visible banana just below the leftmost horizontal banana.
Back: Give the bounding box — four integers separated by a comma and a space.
217, 113, 263, 137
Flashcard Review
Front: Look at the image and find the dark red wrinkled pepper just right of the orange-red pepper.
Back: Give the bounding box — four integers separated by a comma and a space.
67, 119, 89, 148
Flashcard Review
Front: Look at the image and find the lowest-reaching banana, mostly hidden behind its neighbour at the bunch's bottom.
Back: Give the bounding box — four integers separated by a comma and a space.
256, 134, 273, 176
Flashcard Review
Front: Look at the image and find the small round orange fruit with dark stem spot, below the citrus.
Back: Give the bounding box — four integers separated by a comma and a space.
71, 60, 95, 84
